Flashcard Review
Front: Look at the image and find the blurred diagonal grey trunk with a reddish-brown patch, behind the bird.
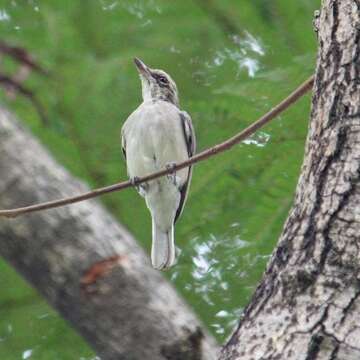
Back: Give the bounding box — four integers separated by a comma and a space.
0, 108, 215, 360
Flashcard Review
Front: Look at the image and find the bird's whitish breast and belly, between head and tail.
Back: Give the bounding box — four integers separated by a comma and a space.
123, 102, 193, 226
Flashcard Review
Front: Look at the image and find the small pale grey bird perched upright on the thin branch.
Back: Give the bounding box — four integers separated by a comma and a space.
121, 58, 196, 270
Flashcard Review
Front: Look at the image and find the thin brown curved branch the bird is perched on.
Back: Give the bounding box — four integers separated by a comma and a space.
0, 76, 314, 218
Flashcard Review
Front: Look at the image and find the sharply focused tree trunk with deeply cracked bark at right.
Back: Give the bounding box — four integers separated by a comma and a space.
220, 0, 360, 360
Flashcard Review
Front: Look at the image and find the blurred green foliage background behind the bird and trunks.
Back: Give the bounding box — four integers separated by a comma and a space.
0, 0, 319, 360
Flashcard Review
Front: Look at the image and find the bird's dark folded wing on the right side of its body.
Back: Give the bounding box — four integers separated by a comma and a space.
175, 111, 196, 222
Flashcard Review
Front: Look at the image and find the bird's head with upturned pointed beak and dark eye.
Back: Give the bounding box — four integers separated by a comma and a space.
134, 58, 179, 107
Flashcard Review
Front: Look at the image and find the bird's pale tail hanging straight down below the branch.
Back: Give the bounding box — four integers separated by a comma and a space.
151, 219, 175, 270
